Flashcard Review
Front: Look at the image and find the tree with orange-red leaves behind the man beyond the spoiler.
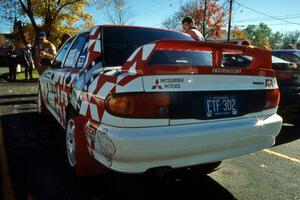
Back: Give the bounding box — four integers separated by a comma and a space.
163, 0, 228, 38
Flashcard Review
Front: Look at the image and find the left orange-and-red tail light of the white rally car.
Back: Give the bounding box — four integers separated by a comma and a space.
105, 93, 170, 118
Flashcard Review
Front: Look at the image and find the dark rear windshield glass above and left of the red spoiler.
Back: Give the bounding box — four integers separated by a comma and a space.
103, 27, 193, 66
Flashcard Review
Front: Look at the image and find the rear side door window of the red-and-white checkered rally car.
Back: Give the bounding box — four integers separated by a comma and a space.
64, 33, 88, 68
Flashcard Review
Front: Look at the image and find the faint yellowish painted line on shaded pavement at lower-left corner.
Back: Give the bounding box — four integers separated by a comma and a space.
0, 121, 15, 200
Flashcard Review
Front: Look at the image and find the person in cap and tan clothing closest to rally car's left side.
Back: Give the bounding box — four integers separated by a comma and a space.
35, 32, 56, 75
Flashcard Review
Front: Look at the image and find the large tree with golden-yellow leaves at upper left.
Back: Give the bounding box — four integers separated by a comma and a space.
0, 0, 109, 44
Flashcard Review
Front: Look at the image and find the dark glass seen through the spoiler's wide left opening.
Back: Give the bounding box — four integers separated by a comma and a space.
148, 50, 212, 66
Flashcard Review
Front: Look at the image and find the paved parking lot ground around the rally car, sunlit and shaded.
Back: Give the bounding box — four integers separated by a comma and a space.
0, 83, 300, 200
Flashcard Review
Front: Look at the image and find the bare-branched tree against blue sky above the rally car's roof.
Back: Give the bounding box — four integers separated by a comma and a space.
105, 0, 134, 25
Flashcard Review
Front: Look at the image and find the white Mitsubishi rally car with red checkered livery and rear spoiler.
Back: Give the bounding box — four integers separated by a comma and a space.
38, 25, 282, 175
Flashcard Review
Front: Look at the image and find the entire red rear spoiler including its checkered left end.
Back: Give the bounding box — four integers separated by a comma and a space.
121, 40, 274, 76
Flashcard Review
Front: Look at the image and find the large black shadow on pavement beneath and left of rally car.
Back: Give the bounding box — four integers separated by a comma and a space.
1, 112, 234, 200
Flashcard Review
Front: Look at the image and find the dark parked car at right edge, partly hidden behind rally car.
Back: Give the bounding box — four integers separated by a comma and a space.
272, 56, 300, 117
